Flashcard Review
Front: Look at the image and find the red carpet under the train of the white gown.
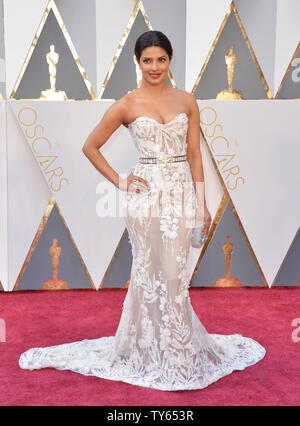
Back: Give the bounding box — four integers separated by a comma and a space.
0, 288, 300, 406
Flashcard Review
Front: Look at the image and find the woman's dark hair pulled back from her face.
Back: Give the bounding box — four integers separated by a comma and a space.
134, 30, 173, 62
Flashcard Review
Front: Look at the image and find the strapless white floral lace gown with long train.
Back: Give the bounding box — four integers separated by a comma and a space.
19, 113, 266, 391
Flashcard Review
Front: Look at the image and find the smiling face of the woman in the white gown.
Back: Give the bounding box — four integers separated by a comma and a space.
139, 46, 171, 85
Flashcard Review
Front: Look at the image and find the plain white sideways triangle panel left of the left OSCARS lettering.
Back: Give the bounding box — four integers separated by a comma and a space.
7, 101, 51, 290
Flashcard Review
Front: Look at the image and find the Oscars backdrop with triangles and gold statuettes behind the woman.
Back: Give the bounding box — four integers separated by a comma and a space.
0, 0, 300, 291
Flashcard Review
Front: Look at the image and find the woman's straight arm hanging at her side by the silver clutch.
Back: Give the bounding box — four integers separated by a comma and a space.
187, 94, 211, 235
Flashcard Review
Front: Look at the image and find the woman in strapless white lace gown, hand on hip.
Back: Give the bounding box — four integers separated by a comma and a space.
19, 31, 265, 391
